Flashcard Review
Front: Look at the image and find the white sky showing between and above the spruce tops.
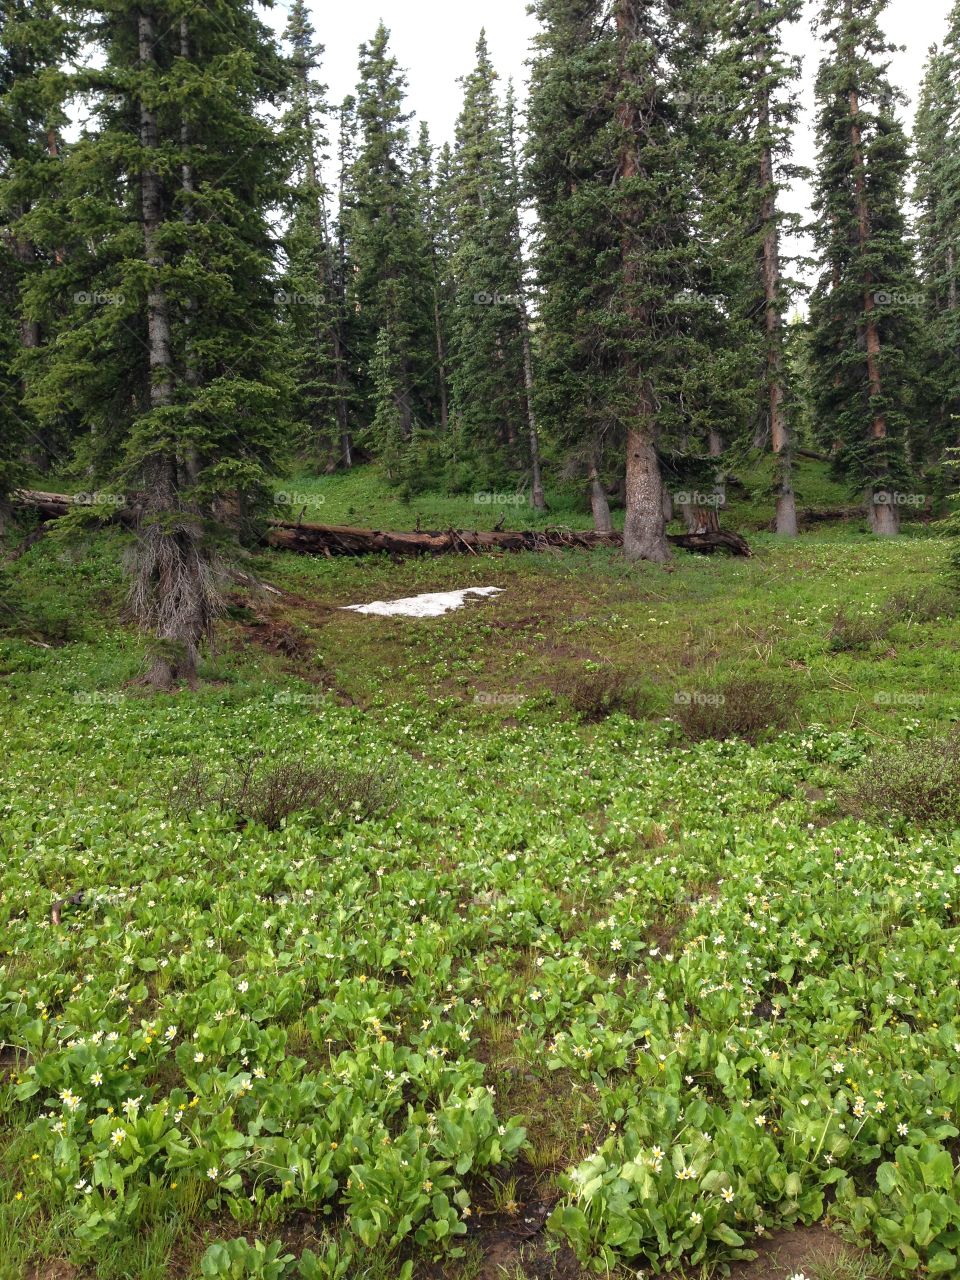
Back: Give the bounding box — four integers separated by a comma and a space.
264, 0, 951, 275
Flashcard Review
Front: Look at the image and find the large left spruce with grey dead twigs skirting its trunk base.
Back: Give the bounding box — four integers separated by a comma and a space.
28, 0, 288, 686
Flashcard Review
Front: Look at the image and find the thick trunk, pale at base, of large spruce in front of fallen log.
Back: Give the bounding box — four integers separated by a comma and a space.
616, 0, 671, 564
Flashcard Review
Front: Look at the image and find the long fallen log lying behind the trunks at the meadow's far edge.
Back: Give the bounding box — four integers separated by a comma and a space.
13, 489, 750, 556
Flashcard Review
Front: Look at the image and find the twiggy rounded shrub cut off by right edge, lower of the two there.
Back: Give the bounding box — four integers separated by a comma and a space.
841, 731, 960, 827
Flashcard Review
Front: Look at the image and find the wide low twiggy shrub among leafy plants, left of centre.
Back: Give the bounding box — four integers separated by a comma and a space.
170, 755, 393, 831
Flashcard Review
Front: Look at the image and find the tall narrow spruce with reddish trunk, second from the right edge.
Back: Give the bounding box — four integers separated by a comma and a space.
810, 0, 922, 535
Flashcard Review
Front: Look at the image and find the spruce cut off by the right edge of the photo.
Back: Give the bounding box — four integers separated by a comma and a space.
914, 4, 960, 449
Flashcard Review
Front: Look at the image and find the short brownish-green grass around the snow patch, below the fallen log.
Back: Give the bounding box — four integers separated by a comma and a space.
249, 530, 960, 735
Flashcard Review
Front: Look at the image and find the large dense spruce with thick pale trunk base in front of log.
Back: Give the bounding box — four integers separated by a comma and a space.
530, 0, 709, 562
